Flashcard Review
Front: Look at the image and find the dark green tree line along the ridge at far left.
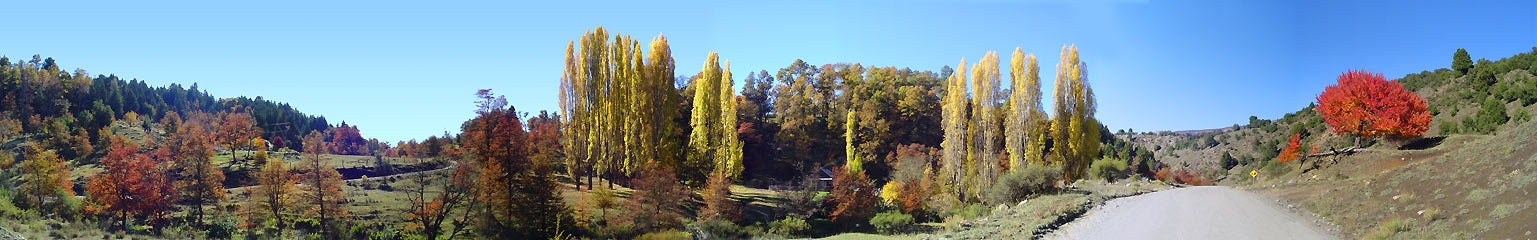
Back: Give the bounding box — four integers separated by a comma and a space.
0, 55, 330, 153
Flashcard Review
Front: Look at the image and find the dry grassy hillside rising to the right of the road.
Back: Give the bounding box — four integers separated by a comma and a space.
1117, 48, 1537, 238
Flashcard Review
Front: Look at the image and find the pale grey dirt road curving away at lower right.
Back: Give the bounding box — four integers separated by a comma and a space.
1047, 186, 1339, 240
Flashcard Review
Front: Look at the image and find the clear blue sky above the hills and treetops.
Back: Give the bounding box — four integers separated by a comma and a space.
0, 0, 1537, 142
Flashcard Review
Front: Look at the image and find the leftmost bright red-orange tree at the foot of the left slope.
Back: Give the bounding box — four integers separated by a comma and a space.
86, 135, 172, 226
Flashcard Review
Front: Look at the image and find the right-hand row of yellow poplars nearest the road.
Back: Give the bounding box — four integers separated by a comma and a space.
941, 46, 1100, 200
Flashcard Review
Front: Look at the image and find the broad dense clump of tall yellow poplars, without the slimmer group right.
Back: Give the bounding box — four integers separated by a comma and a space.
559, 26, 682, 188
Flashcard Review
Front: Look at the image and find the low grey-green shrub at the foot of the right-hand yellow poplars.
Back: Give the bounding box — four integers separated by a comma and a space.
987, 163, 1057, 205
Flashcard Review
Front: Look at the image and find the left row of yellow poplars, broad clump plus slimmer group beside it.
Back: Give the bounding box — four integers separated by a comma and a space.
559, 26, 742, 189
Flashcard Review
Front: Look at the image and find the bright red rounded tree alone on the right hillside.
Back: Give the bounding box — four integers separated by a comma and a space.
1317, 71, 1431, 138
